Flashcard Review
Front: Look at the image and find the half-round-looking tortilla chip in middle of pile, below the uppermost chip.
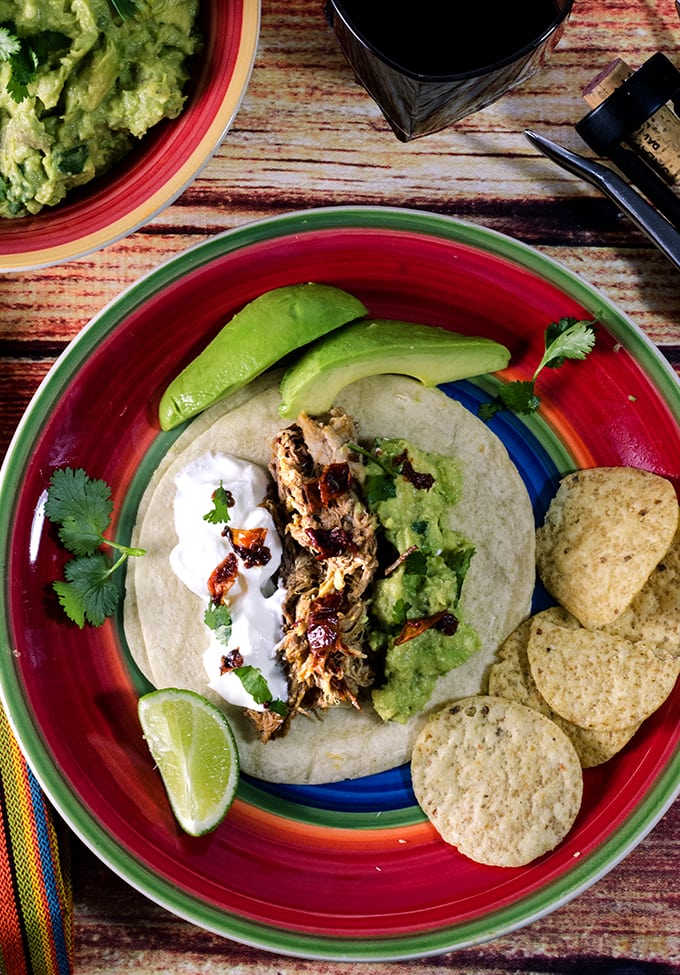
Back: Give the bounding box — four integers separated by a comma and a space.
527, 618, 680, 730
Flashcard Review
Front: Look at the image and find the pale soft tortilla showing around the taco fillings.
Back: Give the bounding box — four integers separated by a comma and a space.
124, 375, 535, 783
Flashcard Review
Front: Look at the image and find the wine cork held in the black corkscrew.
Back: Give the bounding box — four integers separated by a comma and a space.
583, 58, 680, 183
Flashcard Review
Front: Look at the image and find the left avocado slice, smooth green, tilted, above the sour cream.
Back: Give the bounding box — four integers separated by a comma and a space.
158, 282, 367, 430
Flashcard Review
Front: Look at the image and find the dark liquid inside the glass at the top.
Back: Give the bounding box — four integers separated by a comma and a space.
336, 0, 564, 75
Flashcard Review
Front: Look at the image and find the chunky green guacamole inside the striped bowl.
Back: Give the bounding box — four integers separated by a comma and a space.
0, 0, 199, 217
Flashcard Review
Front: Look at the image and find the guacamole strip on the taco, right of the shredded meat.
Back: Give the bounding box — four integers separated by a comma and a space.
365, 440, 480, 722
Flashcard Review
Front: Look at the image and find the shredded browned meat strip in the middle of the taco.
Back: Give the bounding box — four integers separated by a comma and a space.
270, 409, 377, 717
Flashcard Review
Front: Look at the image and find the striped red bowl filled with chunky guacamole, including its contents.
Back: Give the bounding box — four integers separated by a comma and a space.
0, 0, 260, 271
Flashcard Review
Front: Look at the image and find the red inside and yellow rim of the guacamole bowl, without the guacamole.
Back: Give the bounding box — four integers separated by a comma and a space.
0, 0, 260, 271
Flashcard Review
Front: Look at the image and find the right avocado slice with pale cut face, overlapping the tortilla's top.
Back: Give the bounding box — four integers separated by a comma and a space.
279, 319, 510, 418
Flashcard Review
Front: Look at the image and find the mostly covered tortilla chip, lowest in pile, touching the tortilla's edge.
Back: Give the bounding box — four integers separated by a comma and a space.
488, 606, 640, 768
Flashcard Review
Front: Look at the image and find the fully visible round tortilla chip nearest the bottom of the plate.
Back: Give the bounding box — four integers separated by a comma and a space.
411, 695, 583, 867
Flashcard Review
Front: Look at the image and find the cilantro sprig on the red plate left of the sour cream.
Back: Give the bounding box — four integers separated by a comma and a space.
45, 467, 145, 629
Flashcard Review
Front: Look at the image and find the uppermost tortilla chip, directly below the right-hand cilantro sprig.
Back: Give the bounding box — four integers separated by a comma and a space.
536, 467, 679, 629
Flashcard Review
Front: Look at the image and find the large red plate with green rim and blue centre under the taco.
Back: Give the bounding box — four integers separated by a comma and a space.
0, 207, 680, 961
